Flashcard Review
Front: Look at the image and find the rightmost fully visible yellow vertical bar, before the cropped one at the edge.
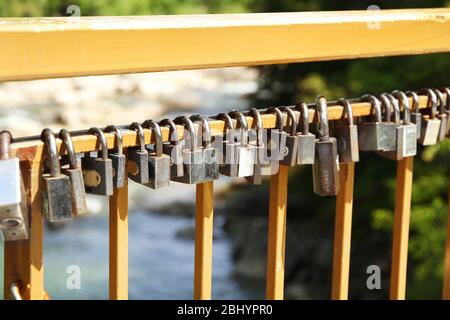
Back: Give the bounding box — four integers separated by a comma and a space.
389, 157, 414, 300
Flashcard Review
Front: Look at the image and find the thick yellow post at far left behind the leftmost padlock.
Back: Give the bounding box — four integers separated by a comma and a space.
4, 158, 44, 300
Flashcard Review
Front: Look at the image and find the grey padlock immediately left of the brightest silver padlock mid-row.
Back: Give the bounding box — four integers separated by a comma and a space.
216, 113, 239, 177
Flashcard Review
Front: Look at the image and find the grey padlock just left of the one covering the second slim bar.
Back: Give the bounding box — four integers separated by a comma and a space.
172, 116, 205, 184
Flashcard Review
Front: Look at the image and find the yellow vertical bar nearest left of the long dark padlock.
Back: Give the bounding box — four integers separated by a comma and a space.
266, 165, 289, 300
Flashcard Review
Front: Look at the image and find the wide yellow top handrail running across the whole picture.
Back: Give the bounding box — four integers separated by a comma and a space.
0, 8, 450, 81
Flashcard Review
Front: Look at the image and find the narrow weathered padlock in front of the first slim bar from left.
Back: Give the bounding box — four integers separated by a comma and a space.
105, 125, 127, 188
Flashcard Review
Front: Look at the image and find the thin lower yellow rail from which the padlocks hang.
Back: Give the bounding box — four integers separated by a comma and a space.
11, 95, 446, 161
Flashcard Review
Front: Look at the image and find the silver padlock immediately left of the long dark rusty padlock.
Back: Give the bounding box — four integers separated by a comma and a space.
295, 102, 316, 165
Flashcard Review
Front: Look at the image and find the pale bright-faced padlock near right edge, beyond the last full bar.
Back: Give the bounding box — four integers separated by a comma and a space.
419, 89, 441, 146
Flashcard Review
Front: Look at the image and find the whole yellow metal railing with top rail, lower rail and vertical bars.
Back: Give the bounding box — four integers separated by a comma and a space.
0, 9, 450, 299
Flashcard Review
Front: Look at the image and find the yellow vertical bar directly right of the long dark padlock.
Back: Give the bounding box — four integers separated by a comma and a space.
331, 162, 355, 300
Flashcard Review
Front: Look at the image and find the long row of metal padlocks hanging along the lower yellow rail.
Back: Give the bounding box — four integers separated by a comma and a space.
0, 88, 450, 241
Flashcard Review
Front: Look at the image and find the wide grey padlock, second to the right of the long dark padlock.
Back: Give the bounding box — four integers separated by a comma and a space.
358, 95, 389, 151
